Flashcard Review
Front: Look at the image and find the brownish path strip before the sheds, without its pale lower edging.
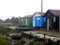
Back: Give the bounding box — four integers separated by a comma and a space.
23, 30, 60, 38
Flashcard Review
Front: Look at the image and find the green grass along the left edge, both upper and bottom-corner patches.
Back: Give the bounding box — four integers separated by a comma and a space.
0, 25, 18, 45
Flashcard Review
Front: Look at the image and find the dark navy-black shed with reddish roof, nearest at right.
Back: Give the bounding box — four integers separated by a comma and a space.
44, 9, 60, 30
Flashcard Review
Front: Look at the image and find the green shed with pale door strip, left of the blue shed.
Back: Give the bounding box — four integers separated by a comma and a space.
21, 15, 32, 27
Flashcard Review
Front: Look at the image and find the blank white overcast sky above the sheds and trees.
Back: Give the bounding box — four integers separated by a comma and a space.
0, 0, 60, 20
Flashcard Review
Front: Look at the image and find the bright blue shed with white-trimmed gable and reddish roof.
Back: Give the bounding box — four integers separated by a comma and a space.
32, 12, 44, 28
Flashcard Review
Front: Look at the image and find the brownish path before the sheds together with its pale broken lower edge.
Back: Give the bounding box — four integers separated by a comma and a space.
23, 30, 60, 41
